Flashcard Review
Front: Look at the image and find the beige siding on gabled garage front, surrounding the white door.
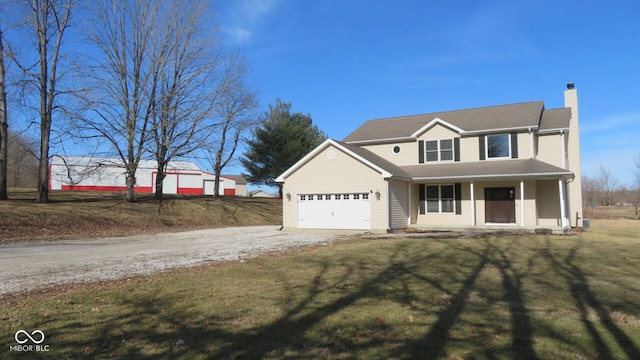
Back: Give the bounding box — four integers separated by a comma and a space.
282, 146, 388, 231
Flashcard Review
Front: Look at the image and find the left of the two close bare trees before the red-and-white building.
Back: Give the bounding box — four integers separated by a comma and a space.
78, 0, 165, 202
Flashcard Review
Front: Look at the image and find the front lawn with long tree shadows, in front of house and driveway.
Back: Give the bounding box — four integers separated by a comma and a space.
0, 220, 640, 359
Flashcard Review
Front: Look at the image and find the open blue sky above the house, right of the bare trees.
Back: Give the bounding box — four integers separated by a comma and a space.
216, 0, 640, 185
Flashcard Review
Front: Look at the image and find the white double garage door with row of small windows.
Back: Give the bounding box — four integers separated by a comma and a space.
298, 193, 371, 230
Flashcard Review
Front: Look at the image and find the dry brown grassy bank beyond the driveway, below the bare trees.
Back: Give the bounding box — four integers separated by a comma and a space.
0, 189, 282, 243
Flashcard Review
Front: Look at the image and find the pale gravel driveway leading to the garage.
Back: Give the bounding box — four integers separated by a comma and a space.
0, 226, 336, 296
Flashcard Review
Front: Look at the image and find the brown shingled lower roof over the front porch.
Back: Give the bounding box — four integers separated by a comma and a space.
401, 159, 574, 181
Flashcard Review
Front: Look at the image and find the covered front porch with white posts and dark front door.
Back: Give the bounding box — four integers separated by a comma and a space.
392, 162, 573, 232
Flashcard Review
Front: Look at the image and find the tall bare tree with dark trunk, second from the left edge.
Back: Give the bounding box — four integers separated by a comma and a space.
6, 0, 75, 202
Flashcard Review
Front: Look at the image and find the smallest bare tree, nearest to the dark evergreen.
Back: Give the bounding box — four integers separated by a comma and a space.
204, 55, 258, 197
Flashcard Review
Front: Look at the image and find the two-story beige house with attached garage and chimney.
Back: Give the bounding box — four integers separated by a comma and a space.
276, 84, 582, 232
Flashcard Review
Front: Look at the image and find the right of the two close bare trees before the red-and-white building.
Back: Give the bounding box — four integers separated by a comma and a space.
149, 0, 227, 200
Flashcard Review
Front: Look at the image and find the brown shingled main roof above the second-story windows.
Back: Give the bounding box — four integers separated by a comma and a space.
343, 101, 544, 143
